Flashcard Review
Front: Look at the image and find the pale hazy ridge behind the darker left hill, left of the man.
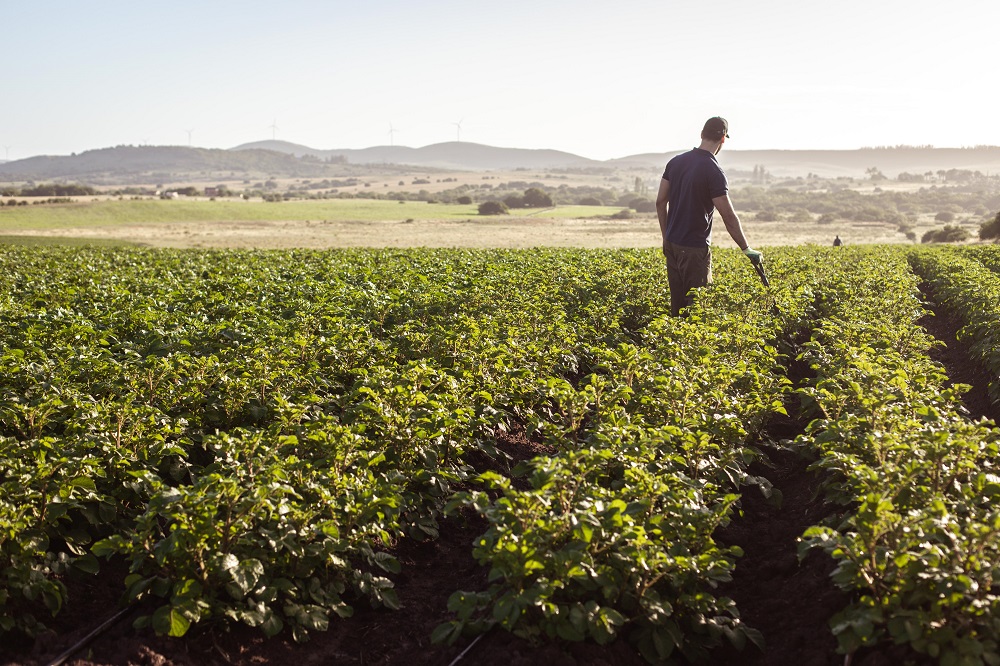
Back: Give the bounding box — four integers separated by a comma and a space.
232, 141, 606, 171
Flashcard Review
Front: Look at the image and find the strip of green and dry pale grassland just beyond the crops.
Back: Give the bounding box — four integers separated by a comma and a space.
0, 199, 952, 249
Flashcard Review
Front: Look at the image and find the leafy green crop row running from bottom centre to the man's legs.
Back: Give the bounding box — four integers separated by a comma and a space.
436, 245, 820, 661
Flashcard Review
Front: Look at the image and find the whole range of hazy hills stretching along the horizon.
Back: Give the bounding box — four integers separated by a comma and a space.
0, 141, 1000, 185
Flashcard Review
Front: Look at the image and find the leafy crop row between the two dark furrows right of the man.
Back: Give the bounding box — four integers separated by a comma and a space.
799, 249, 1000, 664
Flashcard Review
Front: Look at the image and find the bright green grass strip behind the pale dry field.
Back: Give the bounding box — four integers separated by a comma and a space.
0, 199, 620, 228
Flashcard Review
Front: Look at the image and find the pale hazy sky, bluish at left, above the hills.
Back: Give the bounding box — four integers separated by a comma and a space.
0, 0, 1000, 160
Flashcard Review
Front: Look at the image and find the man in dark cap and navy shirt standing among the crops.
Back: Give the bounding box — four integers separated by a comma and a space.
656, 117, 764, 317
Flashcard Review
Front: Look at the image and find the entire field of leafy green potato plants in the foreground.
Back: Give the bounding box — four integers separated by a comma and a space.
0, 241, 1000, 665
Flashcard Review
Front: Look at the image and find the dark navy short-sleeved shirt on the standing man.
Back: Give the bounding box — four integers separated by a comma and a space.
663, 148, 729, 247
